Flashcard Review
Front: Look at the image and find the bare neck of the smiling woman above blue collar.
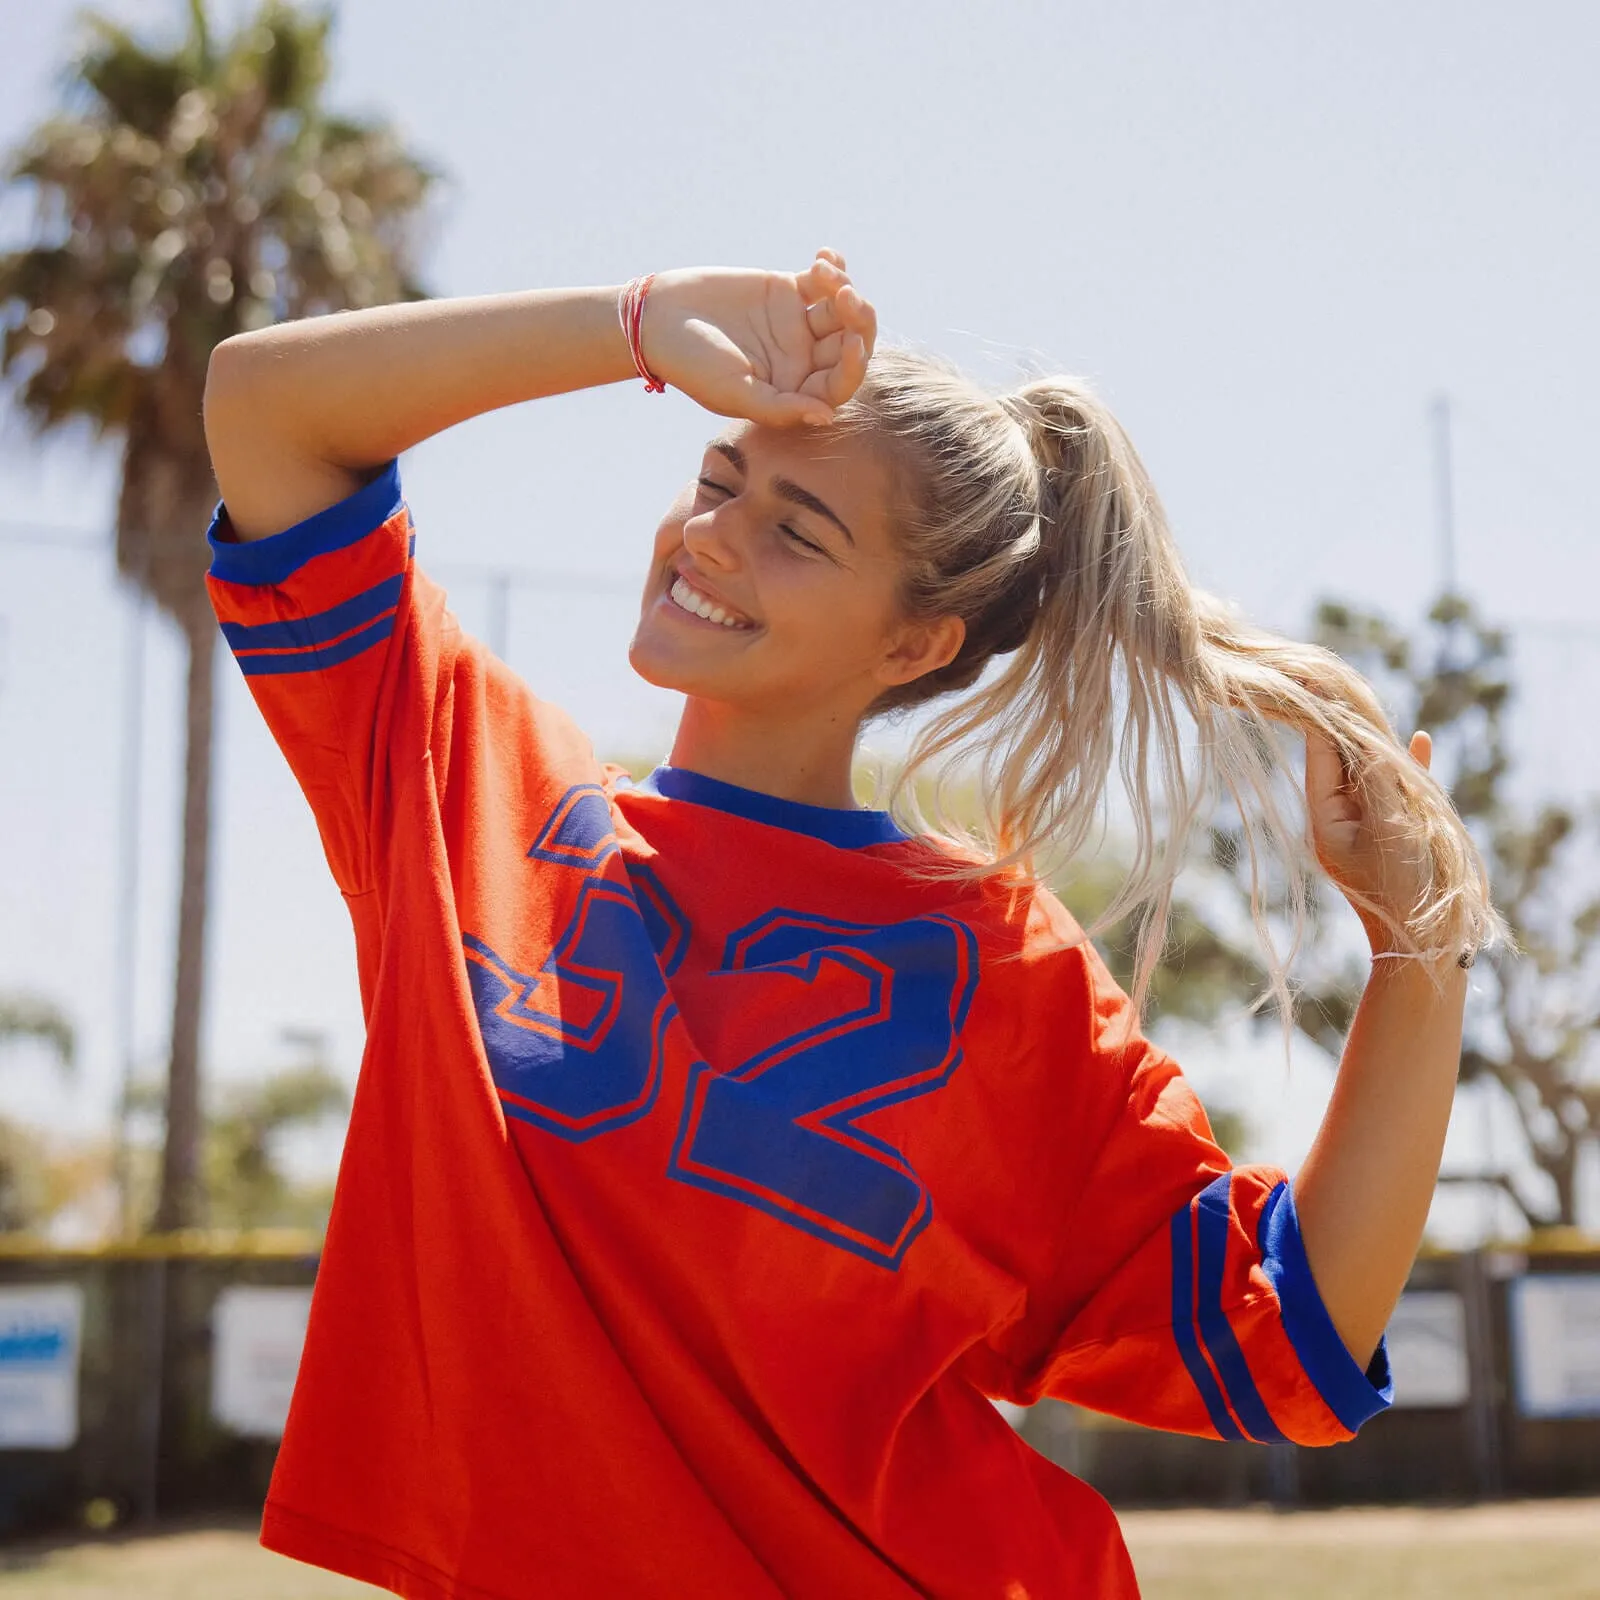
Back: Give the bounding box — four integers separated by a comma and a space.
669, 698, 858, 811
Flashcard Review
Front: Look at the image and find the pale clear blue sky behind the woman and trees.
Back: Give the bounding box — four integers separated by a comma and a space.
0, 0, 1600, 1235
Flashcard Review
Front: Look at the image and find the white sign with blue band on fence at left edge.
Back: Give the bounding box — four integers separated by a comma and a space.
0, 1283, 83, 1450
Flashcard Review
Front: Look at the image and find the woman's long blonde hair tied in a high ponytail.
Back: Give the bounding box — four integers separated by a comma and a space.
840, 350, 1504, 1011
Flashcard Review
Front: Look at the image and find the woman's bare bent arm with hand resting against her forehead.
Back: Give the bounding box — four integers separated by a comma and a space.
205, 251, 875, 539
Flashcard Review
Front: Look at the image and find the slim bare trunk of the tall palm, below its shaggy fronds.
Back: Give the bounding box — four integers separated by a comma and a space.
155, 595, 216, 1232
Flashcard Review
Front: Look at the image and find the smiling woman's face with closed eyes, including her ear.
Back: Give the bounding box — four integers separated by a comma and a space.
629, 422, 962, 726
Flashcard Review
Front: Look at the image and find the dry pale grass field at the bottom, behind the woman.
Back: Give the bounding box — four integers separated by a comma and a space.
0, 1501, 1600, 1600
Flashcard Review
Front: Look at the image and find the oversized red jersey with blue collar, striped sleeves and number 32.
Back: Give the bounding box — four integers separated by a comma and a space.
210, 464, 1389, 1600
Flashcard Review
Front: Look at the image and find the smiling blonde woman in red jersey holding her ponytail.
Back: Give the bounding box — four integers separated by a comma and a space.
206, 251, 1496, 1600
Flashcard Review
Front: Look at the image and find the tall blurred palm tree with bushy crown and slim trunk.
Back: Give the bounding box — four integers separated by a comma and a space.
0, 0, 437, 1229
